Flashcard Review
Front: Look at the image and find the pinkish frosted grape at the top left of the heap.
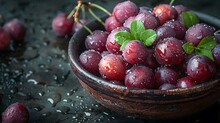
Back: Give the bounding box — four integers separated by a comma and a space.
112, 1, 139, 23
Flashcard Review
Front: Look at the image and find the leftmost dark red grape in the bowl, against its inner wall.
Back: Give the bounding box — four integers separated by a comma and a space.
79, 50, 102, 75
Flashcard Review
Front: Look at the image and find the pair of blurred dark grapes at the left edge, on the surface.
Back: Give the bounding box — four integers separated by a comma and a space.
0, 18, 27, 51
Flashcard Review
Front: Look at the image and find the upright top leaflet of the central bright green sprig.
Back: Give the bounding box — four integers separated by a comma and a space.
131, 20, 145, 40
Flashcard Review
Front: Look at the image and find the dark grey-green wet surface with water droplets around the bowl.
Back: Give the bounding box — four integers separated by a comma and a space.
0, 0, 220, 123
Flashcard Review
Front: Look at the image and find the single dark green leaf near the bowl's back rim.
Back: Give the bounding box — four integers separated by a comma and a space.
181, 11, 199, 28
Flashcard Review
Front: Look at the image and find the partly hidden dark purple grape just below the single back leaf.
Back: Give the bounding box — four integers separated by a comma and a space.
163, 20, 187, 39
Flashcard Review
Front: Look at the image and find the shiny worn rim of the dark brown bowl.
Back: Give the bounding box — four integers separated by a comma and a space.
68, 11, 220, 95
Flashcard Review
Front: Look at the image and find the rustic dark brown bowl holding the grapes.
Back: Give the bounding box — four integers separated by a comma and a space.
68, 12, 220, 119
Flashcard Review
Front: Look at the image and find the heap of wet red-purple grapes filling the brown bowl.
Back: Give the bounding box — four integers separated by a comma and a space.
79, 1, 220, 90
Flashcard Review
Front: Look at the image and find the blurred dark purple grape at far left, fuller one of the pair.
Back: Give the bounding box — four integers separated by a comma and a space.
3, 18, 27, 42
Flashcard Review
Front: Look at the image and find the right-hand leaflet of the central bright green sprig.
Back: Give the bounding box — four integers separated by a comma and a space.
140, 29, 157, 46
